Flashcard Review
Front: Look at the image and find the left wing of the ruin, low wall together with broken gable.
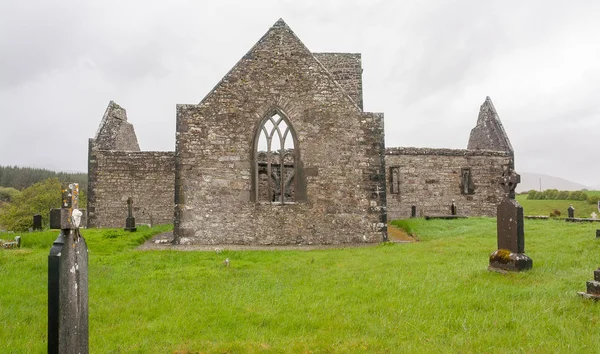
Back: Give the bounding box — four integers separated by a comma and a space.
88, 102, 175, 227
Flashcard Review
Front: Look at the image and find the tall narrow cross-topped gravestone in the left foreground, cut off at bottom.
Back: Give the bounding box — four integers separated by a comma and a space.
48, 183, 89, 354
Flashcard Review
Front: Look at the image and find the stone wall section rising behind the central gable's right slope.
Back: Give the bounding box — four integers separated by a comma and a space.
313, 53, 363, 109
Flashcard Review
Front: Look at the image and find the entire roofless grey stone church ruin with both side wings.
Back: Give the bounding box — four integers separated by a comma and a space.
87, 20, 514, 245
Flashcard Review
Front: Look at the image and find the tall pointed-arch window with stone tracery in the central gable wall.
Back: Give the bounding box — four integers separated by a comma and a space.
254, 112, 298, 204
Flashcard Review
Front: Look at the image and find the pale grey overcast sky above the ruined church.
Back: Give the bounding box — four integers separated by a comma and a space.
0, 0, 600, 186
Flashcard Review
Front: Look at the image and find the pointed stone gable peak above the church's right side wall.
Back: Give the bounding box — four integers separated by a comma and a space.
467, 96, 513, 152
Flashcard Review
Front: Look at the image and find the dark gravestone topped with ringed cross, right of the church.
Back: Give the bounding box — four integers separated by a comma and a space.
488, 166, 533, 271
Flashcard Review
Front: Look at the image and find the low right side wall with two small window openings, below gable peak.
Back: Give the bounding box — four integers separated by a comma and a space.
385, 148, 512, 220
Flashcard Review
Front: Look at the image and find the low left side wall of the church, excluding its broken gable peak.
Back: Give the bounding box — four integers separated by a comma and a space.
87, 140, 175, 228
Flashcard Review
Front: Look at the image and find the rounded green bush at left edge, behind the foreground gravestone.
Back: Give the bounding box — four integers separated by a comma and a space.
0, 178, 62, 231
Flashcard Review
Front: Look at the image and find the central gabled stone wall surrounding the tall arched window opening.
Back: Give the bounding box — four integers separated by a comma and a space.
175, 21, 386, 245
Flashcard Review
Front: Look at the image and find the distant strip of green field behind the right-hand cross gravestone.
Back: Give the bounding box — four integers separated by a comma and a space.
516, 191, 600, 218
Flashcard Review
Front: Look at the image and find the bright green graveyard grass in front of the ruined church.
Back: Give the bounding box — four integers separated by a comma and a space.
0, 218, 600, 353
